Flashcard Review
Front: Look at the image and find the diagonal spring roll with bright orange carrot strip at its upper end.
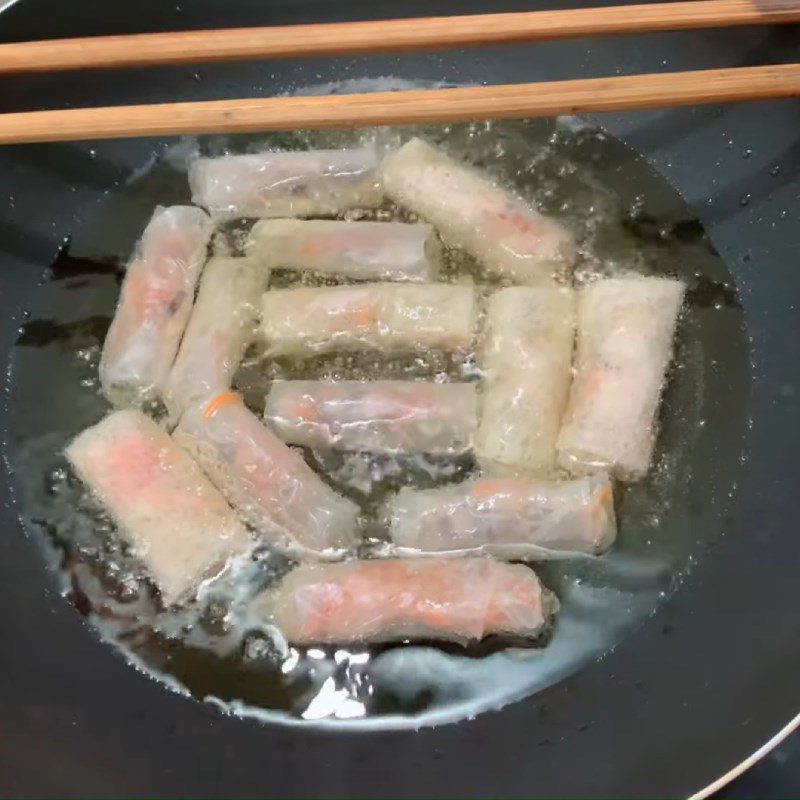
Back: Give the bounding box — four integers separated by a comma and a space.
173, 392, 358, 555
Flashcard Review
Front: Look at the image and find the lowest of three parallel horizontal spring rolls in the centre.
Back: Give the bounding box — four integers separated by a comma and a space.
264, 381, 477, 454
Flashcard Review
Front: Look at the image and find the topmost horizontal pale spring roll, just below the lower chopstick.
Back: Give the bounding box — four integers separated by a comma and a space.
189, 147, 383, 217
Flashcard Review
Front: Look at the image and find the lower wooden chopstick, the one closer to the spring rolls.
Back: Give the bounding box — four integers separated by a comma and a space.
0, 64, 800, 144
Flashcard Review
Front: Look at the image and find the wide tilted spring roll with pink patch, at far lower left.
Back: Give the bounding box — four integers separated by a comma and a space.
66, 409, 250, 605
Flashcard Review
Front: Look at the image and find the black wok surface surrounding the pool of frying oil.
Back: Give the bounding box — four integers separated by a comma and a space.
0, 0, 800, 797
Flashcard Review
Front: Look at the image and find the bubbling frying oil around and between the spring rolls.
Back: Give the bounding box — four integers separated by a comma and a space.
4, 114, 747, 726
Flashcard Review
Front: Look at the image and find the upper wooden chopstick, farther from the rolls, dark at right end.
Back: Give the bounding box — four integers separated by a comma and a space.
0, 0, 800, 74
